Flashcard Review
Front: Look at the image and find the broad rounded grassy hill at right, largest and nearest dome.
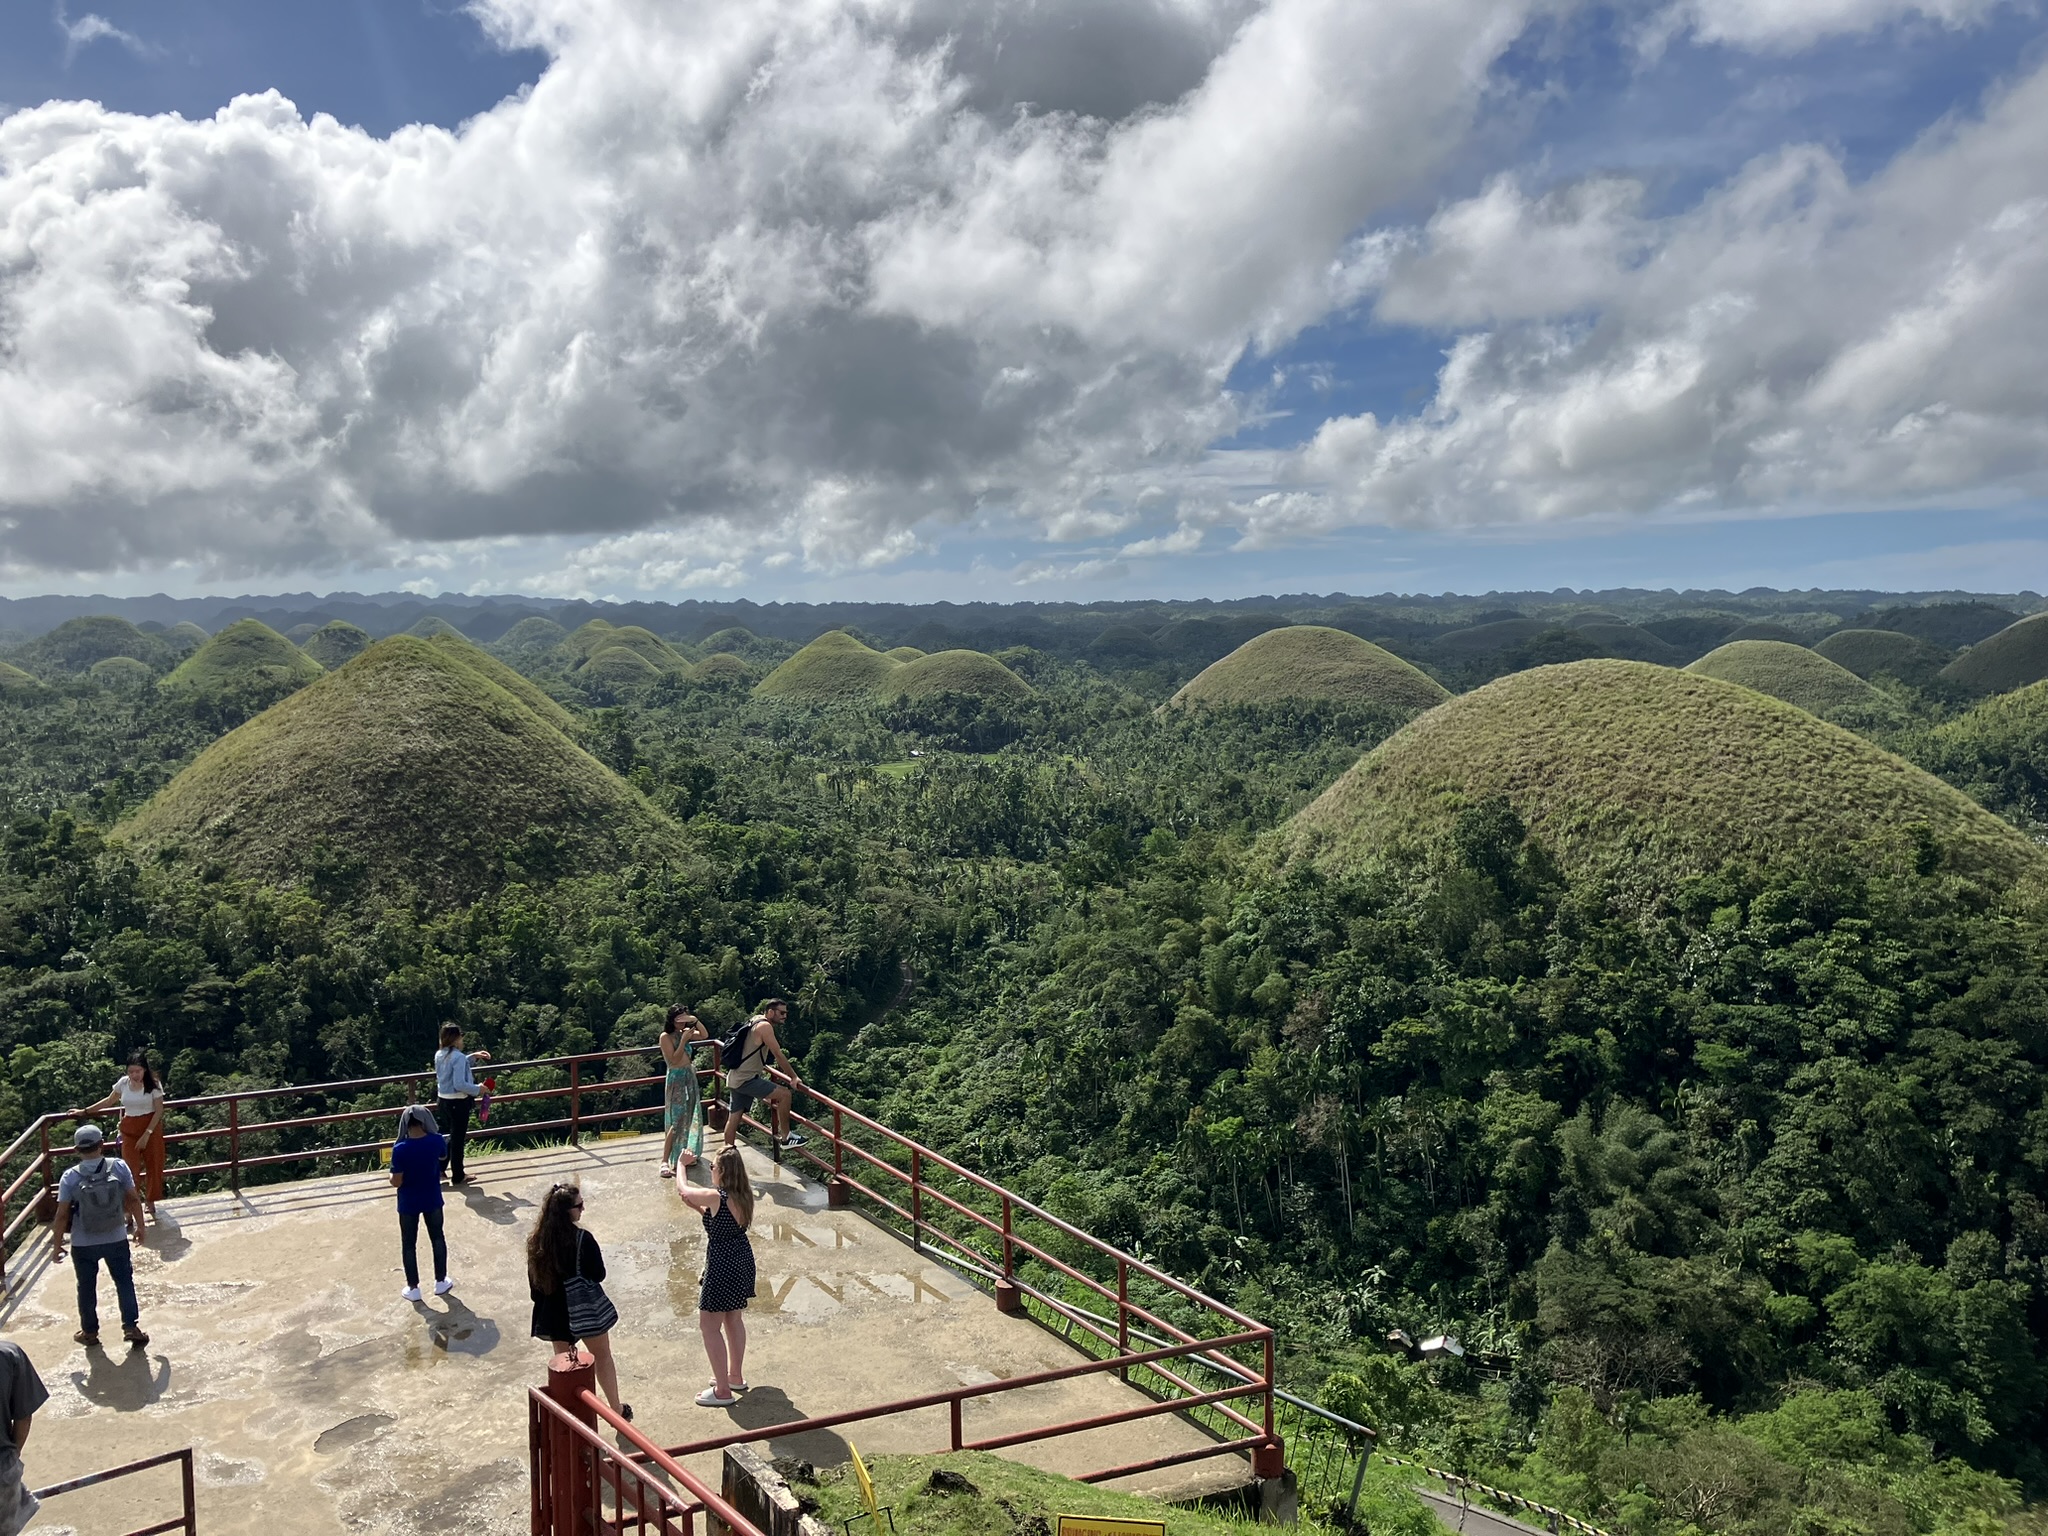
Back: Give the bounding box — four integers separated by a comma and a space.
1282, 662, 2048, 883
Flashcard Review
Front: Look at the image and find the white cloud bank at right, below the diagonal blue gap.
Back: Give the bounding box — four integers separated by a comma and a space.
1241, 60, 2048, 543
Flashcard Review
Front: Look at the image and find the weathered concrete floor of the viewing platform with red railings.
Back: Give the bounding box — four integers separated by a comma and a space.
0, 1137, 1245, 1536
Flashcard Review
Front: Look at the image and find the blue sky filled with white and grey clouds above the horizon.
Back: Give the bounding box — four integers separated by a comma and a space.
0, 0, 2048, 602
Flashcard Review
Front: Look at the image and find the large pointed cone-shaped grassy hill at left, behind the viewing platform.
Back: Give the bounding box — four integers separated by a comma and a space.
119, 635, 682, 899
